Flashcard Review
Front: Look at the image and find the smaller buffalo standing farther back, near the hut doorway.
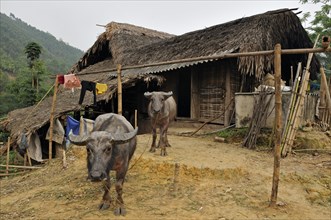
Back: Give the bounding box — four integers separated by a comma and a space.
144, 92, 177, 156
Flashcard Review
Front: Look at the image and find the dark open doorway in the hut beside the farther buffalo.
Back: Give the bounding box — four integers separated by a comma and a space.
177, 71, 191, 118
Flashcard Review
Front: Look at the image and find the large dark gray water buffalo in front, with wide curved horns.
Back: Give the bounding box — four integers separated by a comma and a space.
69, 113, 138, 215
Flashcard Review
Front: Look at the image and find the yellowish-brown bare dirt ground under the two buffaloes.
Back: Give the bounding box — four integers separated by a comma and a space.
0, 125, 331, 219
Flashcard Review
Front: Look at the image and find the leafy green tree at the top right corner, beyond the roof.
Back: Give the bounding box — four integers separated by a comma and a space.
300, 0, 331, 72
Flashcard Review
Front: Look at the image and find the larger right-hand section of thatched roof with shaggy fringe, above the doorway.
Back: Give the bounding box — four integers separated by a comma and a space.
74, 9, 319, 79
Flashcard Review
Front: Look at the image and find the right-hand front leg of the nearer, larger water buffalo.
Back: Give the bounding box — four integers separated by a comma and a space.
114, 166, 127, 216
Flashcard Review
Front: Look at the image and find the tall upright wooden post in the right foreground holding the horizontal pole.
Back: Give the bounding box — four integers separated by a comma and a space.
270, 44, 282, 207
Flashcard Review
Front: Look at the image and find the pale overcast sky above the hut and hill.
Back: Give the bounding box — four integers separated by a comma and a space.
0, 0, 321, 51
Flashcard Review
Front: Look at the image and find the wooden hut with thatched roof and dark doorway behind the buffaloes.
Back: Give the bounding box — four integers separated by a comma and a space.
1, 9, 319, 156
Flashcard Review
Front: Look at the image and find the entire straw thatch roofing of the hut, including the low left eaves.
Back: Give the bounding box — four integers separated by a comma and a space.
3, 9, 318, 147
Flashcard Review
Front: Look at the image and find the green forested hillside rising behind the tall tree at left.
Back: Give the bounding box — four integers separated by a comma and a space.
0, 13, 83, 76
